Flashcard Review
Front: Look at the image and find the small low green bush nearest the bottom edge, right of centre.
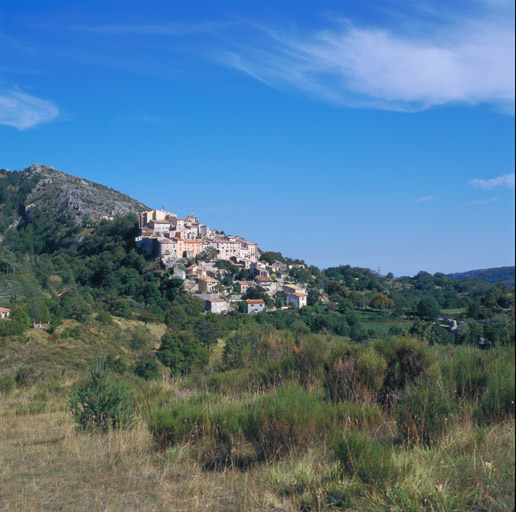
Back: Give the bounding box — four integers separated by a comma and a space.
333, 431, 400, 487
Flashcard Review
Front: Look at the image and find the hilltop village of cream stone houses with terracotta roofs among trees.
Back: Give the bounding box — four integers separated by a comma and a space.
136, 210, 307, 314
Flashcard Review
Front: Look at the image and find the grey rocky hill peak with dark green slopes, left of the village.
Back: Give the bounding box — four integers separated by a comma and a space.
0, 164, 148, 254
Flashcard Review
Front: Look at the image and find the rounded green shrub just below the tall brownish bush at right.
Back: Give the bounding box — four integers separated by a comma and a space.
394, 382, 454, 445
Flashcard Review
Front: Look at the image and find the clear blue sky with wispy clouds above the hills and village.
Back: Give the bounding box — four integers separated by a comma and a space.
0, 0, 515, 275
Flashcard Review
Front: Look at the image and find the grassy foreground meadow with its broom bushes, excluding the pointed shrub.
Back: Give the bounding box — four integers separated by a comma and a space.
0, 321, 514, 511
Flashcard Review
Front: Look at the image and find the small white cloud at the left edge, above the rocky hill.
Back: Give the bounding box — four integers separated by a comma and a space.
0, 90, 59, 130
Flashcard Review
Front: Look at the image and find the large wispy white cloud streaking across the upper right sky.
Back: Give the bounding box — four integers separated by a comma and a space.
218, 7, 515, 113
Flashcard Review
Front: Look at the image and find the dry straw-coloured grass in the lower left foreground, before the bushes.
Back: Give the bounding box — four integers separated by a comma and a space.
0, 391, 290, 512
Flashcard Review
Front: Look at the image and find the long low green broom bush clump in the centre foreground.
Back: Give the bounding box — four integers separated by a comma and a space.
148, 383, 333, 467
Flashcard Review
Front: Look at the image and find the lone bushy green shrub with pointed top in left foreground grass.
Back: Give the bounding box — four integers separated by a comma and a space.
68, 358, 135, 431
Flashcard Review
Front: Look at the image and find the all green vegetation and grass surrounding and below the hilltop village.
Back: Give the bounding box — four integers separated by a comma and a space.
0, 168, 515, 511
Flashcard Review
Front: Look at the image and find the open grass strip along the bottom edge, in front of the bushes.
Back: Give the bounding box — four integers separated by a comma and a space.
0, 383, 514, 512
